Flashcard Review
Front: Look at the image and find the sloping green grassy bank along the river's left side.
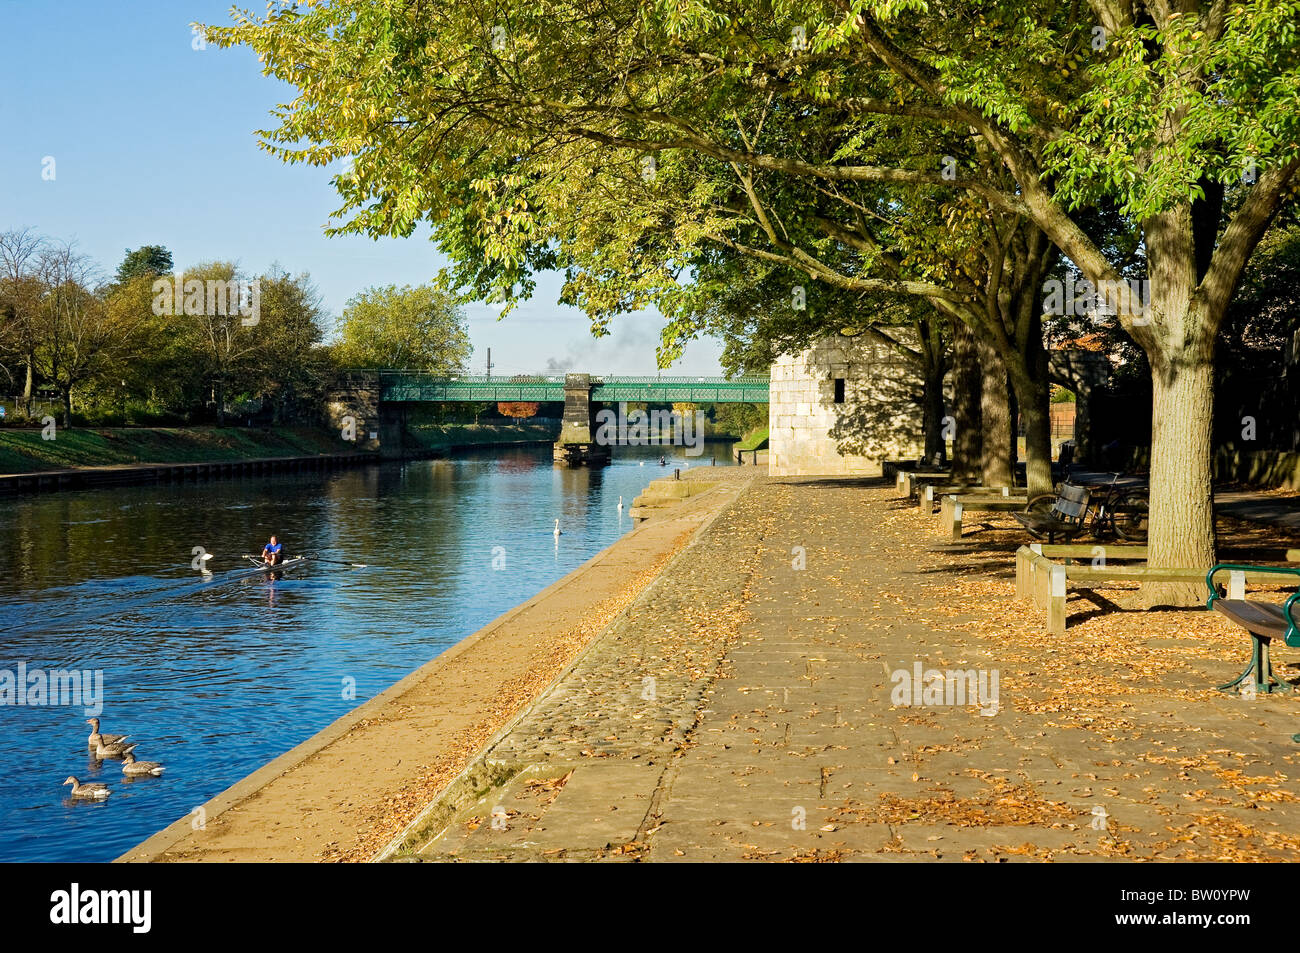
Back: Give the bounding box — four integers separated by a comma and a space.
0, 426, 361, 473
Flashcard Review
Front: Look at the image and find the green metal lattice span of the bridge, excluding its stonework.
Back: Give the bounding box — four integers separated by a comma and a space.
380, 371, 767, 403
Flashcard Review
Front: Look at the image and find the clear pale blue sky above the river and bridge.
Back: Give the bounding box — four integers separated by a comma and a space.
0, 0, 720, 374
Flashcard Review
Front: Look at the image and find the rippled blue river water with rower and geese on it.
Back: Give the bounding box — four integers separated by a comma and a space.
0, 445, 728, 861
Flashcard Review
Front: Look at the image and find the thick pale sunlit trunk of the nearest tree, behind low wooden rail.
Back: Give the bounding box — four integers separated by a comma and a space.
1143, 352, 1214, 606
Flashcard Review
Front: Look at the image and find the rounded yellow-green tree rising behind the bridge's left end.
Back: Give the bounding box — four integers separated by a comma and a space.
335, 285, 471, 373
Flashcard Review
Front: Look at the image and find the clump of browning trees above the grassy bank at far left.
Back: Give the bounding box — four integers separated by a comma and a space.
0, 230, 332, 425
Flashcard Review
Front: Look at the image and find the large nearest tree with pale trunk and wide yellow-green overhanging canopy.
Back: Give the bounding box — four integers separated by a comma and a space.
209, 0, 1300, 602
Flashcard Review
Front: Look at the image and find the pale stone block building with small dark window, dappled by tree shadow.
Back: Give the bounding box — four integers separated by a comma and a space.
768, 329, 923, 476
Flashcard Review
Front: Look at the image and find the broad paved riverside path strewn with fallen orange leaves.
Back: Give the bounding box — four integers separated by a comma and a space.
391, 478, 1300, 862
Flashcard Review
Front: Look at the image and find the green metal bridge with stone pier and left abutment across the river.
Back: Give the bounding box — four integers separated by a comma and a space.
326, 371, 768, 463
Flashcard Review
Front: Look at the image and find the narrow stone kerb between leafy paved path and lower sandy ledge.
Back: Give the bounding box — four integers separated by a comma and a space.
369, 476, 757, 863
